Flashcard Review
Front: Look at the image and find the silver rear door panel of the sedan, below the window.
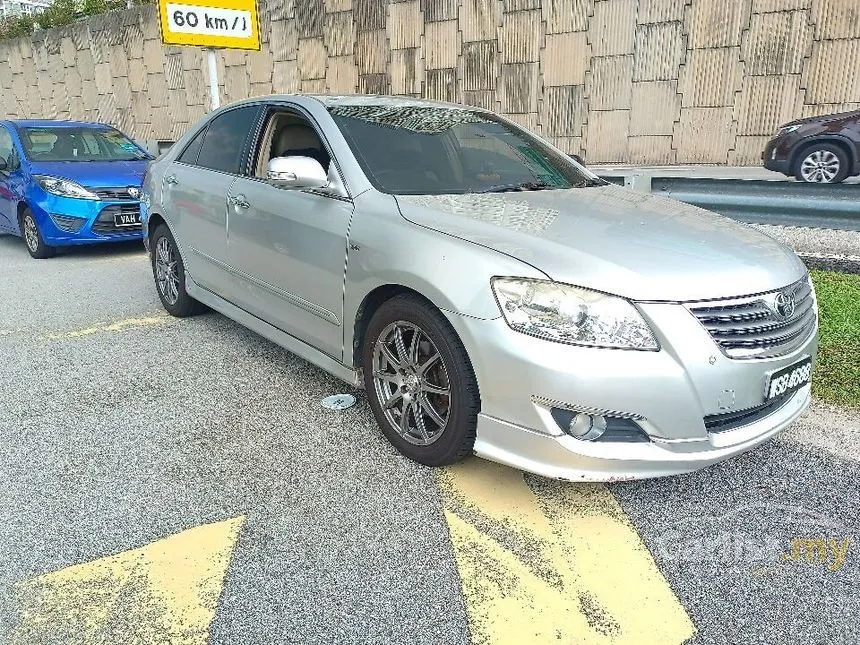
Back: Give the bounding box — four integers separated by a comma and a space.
162, 163, 234, 300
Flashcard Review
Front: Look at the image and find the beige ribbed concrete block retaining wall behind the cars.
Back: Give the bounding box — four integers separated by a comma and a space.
0, 0, 860, 165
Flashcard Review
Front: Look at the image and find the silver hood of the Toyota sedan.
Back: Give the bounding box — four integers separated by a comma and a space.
397, 185, 806, 302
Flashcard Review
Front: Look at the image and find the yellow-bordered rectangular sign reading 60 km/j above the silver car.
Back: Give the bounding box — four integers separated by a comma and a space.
158, 0, 260, 49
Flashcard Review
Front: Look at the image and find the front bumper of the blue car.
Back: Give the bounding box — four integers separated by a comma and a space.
28, 191, 143, 246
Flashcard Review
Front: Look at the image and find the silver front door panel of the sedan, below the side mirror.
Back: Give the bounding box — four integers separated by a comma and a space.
227, 177, 353, 359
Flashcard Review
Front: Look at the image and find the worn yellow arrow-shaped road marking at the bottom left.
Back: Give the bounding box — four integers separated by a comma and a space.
12, 516, 245, 645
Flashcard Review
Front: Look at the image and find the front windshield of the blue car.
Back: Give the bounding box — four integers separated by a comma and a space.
20, 126, 149, 161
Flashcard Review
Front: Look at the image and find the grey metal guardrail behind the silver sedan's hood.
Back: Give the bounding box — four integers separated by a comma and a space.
600, 172, 860, 231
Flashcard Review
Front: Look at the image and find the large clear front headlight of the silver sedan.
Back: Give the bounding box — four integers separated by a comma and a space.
491, 278, 660, 351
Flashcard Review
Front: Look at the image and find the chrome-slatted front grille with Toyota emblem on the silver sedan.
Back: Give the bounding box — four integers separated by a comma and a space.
687, 278, 816, 358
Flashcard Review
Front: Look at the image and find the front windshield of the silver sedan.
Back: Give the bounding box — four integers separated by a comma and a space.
329, 105, 602, 195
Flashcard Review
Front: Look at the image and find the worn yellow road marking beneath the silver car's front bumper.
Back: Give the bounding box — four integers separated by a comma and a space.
440, 460, 695, 645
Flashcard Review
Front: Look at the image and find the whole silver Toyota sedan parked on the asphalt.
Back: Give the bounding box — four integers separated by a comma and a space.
143, 95, 818, 481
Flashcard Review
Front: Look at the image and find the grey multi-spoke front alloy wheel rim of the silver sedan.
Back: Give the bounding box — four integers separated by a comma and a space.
372, 320, 451, 446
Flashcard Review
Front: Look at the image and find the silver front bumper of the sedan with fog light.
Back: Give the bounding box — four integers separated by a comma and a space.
448, 303, 818, 481
